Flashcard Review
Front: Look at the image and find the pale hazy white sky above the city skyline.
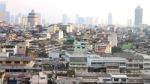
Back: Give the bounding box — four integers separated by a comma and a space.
0, 0, 150, 24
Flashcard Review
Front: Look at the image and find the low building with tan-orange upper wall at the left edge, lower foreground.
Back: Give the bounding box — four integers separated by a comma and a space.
0, 57, 40, 72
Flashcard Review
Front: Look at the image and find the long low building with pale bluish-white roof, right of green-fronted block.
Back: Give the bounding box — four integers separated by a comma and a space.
88, 57, 126, 74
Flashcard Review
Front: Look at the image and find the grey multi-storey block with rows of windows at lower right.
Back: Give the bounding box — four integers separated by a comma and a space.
112, 52, 144, 84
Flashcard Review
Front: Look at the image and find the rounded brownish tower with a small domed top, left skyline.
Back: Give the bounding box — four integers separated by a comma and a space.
28, 10, 40, 28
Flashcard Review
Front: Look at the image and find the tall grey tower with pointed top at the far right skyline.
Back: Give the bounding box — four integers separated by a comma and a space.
134, 6, 143, 27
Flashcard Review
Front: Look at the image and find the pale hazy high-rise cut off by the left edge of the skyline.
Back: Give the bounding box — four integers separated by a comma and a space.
0, 2, 6, 22
